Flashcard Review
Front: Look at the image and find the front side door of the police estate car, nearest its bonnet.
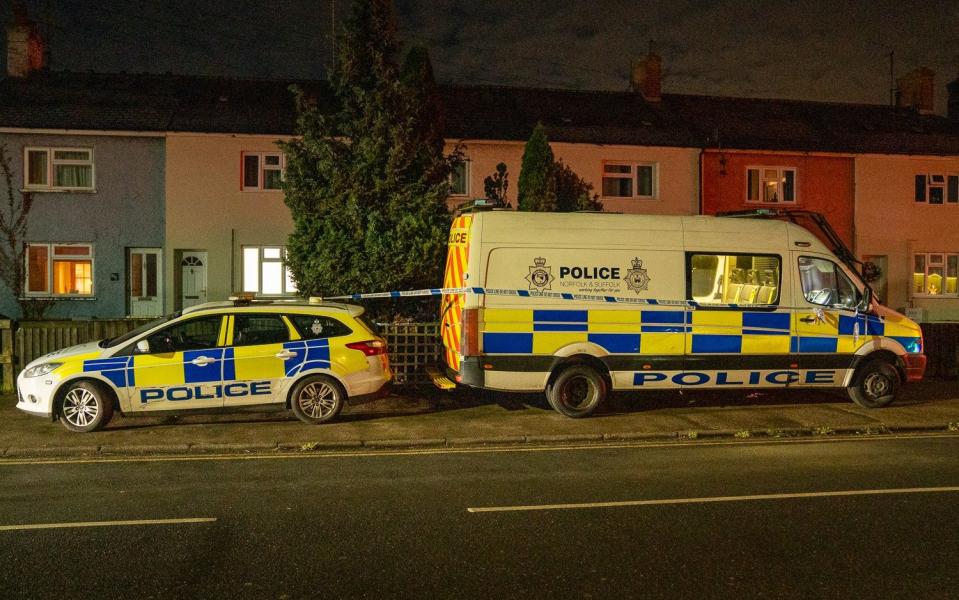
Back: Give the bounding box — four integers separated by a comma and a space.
130, 315, 224, 412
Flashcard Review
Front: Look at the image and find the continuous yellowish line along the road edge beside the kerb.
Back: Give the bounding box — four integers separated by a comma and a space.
0, 433, 959, 468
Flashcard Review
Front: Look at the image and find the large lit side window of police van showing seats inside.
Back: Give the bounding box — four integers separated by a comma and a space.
686, 252, 782, 308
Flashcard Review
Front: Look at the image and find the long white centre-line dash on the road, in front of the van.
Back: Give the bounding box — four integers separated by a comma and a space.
466, 486, 959, 513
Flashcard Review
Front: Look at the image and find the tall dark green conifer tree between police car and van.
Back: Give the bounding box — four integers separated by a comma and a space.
281, 0, 453, 304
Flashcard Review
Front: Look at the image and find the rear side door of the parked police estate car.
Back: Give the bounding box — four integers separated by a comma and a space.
223, 313, 295, 406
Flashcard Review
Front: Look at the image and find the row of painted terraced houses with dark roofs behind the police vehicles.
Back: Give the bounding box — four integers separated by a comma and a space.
0, 28, 959, 320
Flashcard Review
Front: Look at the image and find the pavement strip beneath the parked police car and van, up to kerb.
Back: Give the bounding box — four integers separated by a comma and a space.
0, 380, 959, 460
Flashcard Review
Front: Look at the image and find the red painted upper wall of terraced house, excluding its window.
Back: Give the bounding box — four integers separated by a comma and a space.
702, 150, 855, 252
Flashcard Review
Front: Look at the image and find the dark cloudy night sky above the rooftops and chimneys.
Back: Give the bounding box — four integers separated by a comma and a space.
3, 0, 959, 113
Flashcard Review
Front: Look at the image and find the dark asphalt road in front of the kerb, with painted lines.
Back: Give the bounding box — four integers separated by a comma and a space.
0, 436, 959, 599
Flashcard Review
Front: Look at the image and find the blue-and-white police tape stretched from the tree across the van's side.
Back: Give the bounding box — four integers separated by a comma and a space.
322, 287, 784, 309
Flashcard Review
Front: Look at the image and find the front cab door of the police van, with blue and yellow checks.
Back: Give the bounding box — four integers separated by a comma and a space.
793, 252, 866, 386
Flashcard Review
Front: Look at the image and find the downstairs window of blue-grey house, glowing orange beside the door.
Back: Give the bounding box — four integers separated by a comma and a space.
26, 244, 93, 296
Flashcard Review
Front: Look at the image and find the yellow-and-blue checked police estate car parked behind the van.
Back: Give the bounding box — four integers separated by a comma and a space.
17, 298, 392, 432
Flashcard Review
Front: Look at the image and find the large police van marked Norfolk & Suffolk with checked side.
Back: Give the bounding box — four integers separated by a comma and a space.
441, 210, 926, 417
